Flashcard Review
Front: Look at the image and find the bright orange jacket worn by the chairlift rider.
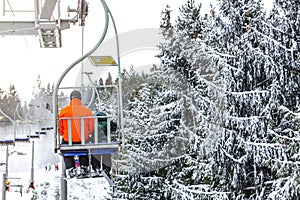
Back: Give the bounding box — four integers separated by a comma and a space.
58, 98, 94, 142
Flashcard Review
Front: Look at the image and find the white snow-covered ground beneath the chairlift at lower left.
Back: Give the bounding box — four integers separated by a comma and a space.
0, 126, 110, 200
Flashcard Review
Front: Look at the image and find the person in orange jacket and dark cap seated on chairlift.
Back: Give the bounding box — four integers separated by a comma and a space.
58, 90, 94, 169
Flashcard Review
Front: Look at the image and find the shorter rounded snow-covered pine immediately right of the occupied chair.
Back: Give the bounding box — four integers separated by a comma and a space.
115, 72, 186, 199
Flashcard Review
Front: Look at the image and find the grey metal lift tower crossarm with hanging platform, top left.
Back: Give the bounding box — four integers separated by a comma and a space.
0, 0, 88, 48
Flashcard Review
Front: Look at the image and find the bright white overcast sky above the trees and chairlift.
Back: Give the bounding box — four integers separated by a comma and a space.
0, 0, 271, 101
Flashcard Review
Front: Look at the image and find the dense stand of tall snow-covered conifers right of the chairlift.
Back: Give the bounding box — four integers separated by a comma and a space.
115, 0, 300, 199
